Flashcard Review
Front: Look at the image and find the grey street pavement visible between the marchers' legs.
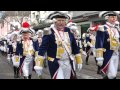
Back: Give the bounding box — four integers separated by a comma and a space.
0, 54, 120, 79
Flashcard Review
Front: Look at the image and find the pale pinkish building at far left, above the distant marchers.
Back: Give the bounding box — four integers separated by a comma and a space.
0, 11, 30, 37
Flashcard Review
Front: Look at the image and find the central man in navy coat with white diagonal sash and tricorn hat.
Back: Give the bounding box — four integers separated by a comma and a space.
36, 11, 82, 79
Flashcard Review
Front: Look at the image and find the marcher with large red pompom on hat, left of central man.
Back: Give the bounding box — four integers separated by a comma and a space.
16, 22, 38, 79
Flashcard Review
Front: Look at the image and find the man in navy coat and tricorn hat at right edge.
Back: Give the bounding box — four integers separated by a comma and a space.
96, 11, 120, 79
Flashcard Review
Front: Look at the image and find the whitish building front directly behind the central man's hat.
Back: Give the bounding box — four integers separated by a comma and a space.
31, 11, 71, 30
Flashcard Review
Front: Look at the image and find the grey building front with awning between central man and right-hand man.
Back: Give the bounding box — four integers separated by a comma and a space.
73, 11, 105, 36
